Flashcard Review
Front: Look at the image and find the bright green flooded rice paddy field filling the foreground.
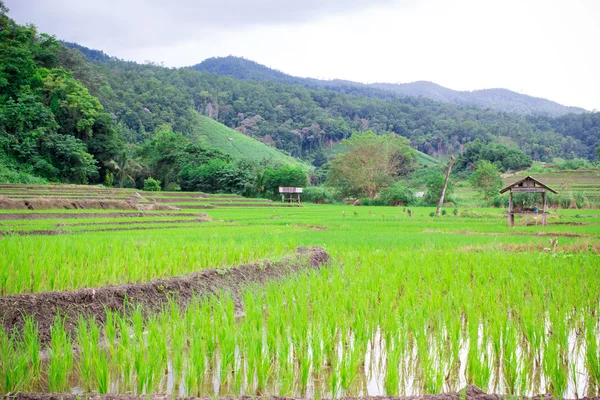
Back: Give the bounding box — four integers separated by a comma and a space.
0, 186, 600, 398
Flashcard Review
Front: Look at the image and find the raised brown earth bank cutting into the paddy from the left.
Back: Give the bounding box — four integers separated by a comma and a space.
0, 247, 330, 343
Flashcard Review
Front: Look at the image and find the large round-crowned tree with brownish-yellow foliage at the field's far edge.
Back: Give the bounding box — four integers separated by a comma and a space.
328, 131, 415, 200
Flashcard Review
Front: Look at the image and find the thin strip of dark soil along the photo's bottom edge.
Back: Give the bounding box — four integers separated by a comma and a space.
4, 385, 600, 400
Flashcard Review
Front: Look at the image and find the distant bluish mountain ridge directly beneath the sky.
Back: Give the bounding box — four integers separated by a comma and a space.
193, 56, 586, 117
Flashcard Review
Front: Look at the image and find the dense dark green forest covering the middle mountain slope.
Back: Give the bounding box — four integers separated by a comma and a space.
63, 45, 600, 165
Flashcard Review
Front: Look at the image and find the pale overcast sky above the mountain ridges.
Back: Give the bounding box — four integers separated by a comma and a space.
5, 0, 600, 110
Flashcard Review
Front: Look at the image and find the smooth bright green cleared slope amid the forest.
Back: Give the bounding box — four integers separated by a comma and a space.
198, 116, 310, 169
